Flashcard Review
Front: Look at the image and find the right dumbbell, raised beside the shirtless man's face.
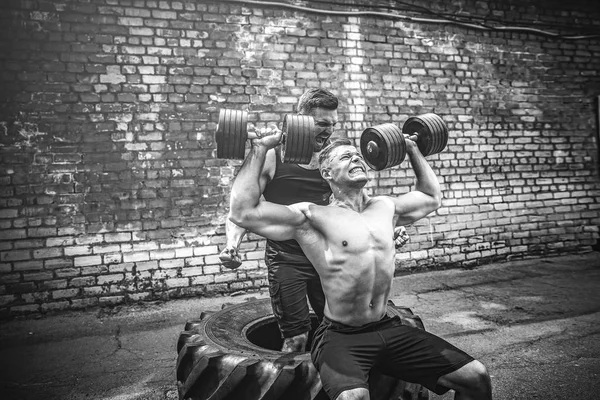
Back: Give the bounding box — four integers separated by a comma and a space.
360, 113, 448, 171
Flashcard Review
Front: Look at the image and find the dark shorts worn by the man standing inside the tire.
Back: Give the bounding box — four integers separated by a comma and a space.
265, 251, 325, 338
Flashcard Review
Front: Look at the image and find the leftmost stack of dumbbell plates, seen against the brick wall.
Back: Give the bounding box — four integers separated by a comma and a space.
215, 109, 248, 160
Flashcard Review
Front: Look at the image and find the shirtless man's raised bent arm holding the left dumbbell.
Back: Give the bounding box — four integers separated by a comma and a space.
229, 143, 306, 240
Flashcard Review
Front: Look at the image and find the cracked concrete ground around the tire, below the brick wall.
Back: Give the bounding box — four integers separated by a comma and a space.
0, 253, 600, 400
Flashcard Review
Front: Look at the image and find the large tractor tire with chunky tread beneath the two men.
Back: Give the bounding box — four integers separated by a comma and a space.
177, 299, 429, 400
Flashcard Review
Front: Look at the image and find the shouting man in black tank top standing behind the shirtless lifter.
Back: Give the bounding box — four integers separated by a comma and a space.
220, 89, 408, 352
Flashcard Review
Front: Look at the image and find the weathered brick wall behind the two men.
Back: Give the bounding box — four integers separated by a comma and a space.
0, 0, 600, 316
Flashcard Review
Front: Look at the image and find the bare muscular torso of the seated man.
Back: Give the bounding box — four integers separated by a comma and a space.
297, 197, 395, 326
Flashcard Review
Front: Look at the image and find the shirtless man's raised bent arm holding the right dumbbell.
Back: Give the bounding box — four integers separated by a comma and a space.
392, 140, 442, 225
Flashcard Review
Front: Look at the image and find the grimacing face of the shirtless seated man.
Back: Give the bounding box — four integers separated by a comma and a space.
328, 146, 369, 188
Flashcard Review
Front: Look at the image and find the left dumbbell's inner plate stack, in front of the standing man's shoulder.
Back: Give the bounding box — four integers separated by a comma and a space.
281, 114, 315, 164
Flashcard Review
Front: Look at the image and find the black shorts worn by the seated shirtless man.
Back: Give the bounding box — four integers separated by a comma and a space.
311, 316, 474, 399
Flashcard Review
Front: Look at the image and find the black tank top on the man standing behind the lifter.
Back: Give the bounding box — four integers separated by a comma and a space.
263, 149, 331, 255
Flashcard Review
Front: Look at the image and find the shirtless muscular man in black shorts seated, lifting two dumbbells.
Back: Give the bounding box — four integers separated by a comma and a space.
230, 132, 492, 400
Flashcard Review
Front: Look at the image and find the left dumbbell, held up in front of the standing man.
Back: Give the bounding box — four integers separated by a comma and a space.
215, 109, 315, 164
